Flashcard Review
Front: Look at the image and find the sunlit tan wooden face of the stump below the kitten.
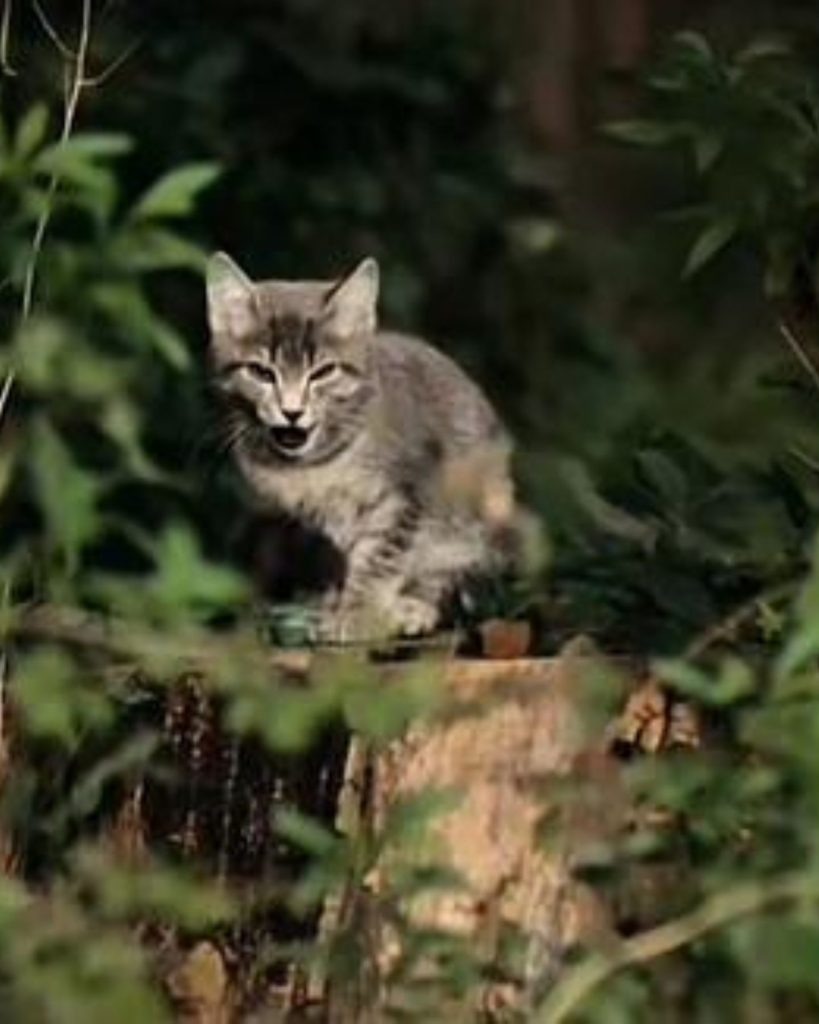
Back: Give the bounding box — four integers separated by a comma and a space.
325, 649, 623, 1021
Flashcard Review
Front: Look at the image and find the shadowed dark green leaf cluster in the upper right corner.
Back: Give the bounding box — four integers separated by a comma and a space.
608, 32, 819, 298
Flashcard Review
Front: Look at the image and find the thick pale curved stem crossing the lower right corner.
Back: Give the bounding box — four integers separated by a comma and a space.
533, 872, 819, 1024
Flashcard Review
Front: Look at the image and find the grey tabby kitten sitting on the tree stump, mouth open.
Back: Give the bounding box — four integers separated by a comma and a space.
206, 253, 514, 642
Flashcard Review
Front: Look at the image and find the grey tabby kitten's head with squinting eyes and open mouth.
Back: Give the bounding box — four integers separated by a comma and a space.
207, 253, 379, 464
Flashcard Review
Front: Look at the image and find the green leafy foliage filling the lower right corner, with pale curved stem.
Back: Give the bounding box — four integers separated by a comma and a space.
538, 540, 819, 1024
